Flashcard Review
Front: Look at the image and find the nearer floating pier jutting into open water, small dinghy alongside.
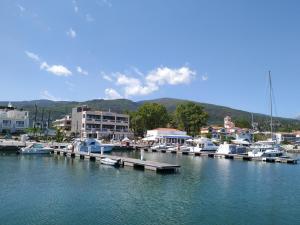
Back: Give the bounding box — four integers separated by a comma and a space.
53, 149, 180, 173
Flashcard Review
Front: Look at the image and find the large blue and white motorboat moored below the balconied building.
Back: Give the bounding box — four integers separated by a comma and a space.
68, 138, 115, 153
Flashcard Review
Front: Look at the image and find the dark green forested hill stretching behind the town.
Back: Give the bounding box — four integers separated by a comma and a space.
0, 98, 300, 128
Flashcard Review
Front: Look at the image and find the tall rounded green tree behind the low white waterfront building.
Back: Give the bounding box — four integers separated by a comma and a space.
175, 102, 208, 136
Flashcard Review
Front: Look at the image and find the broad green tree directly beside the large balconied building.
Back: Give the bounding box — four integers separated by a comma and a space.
130, 103, 170, 136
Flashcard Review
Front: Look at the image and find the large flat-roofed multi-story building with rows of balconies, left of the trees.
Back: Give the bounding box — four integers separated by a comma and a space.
71, 105, 133, 140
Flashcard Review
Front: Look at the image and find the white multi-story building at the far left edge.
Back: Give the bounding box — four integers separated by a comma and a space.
0, 104, 29, 133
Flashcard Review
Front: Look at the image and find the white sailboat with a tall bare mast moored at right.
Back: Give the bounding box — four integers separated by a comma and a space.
248, 71, 284, 158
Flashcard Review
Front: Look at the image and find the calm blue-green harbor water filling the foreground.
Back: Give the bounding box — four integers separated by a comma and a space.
0, 153, 300, 225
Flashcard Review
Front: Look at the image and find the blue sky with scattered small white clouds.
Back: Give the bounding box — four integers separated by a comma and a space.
0, 0, 300, 117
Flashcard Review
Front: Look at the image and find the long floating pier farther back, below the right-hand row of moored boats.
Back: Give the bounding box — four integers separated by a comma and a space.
144, 148, 298, 164
